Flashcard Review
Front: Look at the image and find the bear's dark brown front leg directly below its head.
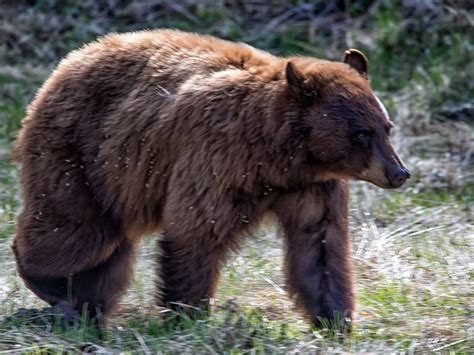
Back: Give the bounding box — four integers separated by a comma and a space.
274, 181, 354, 327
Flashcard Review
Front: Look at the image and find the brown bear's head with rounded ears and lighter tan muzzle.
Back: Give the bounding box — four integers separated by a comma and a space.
286, 49, 410, 188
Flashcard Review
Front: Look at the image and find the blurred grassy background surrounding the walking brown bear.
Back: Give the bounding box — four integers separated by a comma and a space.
0, 0, 474, 353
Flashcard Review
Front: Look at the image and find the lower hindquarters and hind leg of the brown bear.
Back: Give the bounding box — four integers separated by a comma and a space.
13, 207, 134, 324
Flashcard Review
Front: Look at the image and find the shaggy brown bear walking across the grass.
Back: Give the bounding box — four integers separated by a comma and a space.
13, 30, 410, 325
